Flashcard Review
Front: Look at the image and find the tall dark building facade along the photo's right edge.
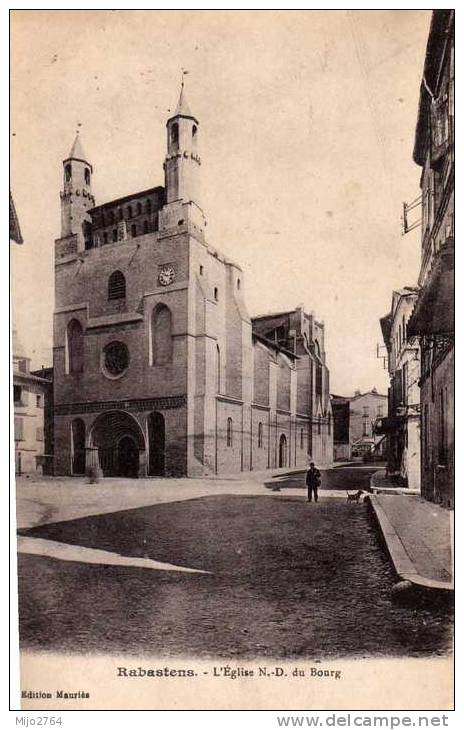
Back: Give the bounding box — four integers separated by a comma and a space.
407, 10, 454, 507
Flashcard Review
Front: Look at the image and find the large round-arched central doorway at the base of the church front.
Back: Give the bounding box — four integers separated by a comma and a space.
90, 411, 145, 478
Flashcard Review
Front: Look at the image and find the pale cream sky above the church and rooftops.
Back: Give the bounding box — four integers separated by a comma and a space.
11, 10, 431, 395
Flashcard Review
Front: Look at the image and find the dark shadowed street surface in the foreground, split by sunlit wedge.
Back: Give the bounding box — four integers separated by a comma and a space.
18, 492, 451, 658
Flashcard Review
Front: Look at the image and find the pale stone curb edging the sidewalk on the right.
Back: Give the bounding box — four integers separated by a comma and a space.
367, 494, 454, 595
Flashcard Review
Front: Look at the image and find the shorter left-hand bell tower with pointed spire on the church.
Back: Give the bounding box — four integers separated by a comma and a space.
60, 132, 95, 251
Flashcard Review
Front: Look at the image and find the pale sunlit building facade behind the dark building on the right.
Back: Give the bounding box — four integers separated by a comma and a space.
375, 287, 421, 490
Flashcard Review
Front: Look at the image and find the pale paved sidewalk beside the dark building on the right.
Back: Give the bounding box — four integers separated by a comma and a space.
369, 493, 454, 591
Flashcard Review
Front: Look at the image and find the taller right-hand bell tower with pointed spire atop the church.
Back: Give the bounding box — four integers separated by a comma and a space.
164, 81, 201, 206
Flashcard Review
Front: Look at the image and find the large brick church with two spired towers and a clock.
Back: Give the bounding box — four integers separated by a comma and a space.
53, 88, 333, 477
